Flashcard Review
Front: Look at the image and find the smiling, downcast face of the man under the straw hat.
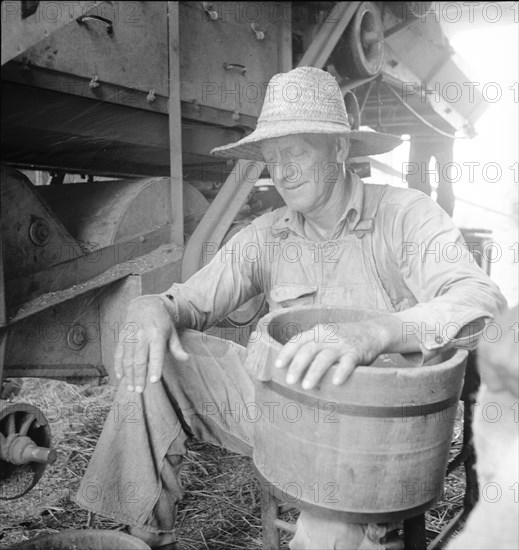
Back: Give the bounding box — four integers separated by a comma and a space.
261, 134, 347, 214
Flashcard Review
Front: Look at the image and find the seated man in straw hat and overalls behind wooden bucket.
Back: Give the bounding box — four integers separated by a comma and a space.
77, 67, 504, 549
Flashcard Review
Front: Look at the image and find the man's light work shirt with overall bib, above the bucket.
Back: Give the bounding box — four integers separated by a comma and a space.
162, 172, 506, 358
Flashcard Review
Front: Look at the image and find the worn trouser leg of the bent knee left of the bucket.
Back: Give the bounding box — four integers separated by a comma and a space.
76, 331, 254, 536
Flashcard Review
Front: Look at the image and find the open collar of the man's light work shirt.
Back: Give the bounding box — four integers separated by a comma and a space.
272, 170, 364, 236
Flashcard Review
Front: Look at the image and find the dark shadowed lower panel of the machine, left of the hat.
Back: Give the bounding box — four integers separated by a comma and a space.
2, 78, 248, 178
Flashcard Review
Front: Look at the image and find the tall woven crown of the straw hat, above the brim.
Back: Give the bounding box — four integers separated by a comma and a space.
258, 67, 351, 132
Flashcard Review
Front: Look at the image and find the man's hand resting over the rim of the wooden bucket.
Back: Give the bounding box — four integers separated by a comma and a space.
275, 315, 419, 390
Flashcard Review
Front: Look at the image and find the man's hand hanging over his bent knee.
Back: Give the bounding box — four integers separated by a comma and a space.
114, 296, 189, 393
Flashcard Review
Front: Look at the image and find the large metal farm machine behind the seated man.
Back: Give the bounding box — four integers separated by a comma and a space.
0, 1, 485, 508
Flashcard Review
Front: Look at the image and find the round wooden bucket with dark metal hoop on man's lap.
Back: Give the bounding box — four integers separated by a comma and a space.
247, 306, 467, 523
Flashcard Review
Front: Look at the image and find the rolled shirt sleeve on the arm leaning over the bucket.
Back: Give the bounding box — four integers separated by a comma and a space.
383, 191, 506, 356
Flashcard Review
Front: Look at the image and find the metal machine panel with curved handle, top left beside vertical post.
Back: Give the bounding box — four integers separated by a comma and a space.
17, 2, 168, 96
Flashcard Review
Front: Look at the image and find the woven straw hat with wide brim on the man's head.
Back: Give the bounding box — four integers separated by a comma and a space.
211, 67, 401, 161
